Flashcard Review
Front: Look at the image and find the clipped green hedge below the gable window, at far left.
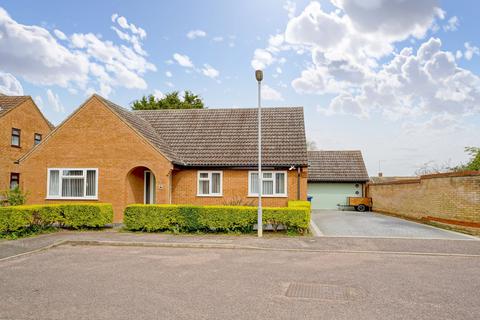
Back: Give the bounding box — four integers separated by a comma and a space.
0, 203, 113, 233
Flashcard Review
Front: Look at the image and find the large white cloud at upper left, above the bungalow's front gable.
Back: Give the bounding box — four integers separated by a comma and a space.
0, 8, 156, 95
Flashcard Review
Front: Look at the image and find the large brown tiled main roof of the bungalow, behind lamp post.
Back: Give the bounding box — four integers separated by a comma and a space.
133, 107, 308, 167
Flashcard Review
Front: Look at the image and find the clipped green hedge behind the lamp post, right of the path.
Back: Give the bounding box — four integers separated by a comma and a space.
123, 204, 310, 233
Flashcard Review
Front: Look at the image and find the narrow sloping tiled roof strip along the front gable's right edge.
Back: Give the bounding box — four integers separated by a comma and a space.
96, 95, 183, 163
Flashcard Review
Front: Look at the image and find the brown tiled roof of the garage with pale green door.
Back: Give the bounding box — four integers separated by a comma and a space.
308, 150, 369, 182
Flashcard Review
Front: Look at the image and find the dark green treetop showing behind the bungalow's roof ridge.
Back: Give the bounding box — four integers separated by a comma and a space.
132, 90, 204, 110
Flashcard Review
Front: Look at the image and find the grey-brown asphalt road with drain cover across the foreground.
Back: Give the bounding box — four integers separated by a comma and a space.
0, 241, 480, 320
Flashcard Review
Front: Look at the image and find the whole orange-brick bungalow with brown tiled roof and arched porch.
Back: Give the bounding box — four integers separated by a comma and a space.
19, 95, 308, 222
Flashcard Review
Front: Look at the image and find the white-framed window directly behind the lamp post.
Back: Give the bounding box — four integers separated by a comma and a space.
248, 171, 287, 197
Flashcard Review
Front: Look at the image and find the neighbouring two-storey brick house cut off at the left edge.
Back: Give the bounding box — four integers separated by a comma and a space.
0, 94, 53, 191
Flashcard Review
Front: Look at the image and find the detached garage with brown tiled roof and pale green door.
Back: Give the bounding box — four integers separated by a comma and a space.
308, 150, 369, 209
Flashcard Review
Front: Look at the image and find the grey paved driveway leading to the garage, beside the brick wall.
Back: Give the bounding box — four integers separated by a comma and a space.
312, 210, 478, 240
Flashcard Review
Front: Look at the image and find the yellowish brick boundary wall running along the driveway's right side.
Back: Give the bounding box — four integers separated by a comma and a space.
367, 171, 480, 234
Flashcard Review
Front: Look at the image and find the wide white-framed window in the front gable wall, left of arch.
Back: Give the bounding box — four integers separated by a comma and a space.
47, 168, 98, 199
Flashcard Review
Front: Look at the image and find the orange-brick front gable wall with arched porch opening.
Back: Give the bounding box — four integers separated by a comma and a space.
20, 97, 172, 222
